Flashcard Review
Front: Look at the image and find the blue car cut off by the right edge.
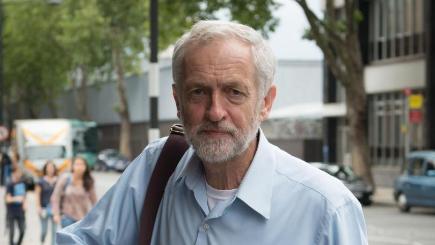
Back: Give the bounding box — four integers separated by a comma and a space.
394, 151, 435, 212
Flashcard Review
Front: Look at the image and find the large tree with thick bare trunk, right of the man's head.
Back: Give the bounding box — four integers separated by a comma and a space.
295, 0, 375, 187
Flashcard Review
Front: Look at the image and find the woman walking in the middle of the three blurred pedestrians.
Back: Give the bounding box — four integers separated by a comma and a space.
35, 161, 57, 244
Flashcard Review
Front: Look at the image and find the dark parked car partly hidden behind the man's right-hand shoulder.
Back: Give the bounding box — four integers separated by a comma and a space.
311, 162, 373, 205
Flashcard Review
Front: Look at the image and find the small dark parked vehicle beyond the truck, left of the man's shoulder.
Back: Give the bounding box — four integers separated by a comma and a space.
94, 149, 130, 172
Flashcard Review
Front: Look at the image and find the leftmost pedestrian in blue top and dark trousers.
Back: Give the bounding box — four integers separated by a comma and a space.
5, 166, 26, 245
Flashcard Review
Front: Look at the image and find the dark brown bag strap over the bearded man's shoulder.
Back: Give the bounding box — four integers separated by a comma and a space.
138, 124, 189, 245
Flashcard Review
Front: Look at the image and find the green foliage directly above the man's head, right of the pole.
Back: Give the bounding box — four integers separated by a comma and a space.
159, 0, 280, 48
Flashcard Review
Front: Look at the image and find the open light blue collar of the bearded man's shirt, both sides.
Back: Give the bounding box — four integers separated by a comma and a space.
176, 129, 276, 219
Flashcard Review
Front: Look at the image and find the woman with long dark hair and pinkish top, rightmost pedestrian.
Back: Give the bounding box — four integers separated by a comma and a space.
51, 157, 97, 227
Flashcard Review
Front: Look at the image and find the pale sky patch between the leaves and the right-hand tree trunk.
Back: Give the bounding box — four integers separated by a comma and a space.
269, 0, 323, 60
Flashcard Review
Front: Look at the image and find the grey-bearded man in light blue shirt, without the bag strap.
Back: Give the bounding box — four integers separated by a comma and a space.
57, 21, 367, 245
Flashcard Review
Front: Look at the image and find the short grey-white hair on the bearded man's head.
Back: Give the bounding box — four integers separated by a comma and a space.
172, 20, 275, 97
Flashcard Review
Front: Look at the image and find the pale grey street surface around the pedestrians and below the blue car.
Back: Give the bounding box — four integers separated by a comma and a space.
0, 173, 435, 245
